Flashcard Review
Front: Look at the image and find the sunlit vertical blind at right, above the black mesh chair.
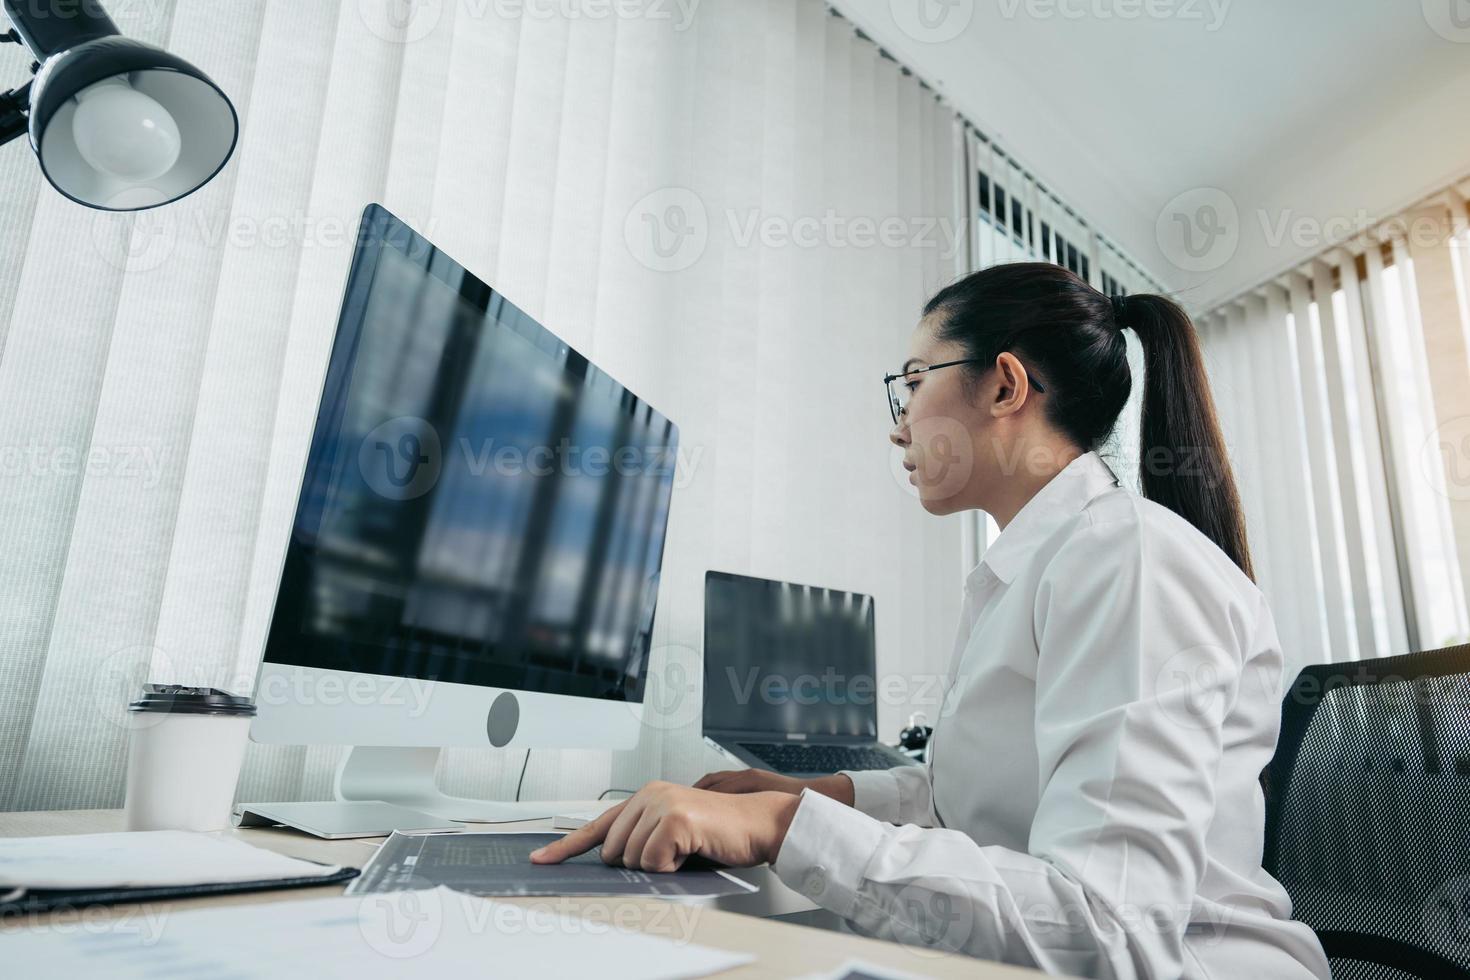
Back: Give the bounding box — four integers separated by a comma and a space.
1200, 185, 1470, 675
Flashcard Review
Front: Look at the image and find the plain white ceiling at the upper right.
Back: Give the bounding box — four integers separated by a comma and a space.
832, 0, 1470, 310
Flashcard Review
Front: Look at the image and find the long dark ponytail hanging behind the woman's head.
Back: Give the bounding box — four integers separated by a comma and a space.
1117, 295, 1255, 579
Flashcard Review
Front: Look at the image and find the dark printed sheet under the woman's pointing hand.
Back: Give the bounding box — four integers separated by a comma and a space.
347, 833, 757, 898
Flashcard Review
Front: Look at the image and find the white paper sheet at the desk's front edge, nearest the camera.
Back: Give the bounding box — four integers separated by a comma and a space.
3, 887, 754, 980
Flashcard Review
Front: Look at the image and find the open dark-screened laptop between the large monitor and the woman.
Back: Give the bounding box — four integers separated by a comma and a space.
704, 572, 917, 777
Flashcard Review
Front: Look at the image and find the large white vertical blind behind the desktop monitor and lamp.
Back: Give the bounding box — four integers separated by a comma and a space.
0, 0, 987, 810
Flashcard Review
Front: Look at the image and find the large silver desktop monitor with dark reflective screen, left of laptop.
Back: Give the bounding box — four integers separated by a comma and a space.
251, 206, 678, 815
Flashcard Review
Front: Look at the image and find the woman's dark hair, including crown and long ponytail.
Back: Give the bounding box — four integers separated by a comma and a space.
925, 262, 1254, 579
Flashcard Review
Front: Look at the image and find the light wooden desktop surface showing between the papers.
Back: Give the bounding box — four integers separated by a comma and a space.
0, 804, 1042, 980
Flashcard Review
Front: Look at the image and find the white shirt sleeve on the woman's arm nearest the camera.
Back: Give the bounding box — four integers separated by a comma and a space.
775, 522, 1244, 977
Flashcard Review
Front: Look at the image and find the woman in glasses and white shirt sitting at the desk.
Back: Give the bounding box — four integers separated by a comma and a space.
534, 263, 1329, 979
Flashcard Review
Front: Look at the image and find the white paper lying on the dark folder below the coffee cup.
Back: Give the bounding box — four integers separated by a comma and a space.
0, 830, 340, 890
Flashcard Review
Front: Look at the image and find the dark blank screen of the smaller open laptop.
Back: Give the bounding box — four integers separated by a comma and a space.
704, 572, 878, 739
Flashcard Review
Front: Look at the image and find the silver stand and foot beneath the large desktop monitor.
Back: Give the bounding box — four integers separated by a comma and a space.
332, 745, 557, 824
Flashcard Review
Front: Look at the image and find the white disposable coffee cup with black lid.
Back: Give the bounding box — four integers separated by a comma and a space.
123, 685, 256, 830
